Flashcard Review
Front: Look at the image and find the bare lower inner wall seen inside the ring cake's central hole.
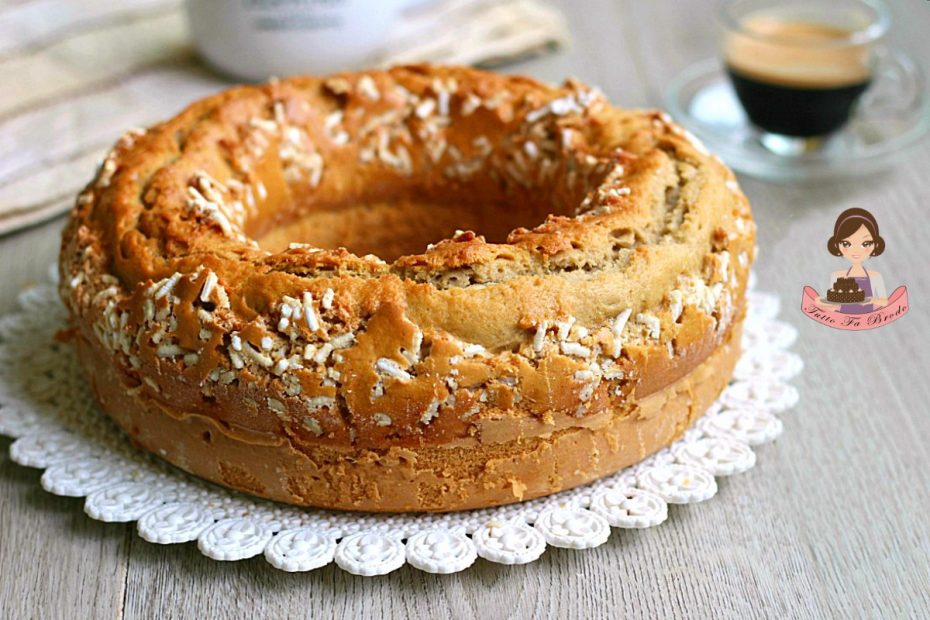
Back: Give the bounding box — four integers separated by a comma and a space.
256, 196, 553, 262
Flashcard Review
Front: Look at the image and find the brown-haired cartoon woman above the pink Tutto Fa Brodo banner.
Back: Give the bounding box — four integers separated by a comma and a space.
822, 208, 888, 314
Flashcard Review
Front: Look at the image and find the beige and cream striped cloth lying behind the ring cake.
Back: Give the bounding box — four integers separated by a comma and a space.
0, 0, 568, 235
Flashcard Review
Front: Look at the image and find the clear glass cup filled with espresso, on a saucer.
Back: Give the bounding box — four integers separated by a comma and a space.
720, 0, 890, 154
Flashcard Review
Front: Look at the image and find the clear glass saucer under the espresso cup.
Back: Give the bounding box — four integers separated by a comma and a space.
666, 52, 930, 181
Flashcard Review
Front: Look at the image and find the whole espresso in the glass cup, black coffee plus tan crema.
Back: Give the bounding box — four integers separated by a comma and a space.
724, 16, 871, 137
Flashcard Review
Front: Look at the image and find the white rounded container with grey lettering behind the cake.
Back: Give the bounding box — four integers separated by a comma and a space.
187, 0, 423, 80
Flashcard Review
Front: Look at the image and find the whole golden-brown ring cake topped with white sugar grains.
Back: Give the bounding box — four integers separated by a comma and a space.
60, 66, 755, 511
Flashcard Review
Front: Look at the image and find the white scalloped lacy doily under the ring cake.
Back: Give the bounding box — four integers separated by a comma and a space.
0, 266, 803, 575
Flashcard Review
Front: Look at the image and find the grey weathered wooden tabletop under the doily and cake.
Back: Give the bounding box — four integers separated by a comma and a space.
0, 0, 930, 618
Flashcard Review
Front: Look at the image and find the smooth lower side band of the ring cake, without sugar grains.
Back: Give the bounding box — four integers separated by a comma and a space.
70, 310, 742, 512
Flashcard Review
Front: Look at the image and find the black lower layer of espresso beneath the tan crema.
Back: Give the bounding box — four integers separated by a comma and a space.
727, 66, 869, 137
